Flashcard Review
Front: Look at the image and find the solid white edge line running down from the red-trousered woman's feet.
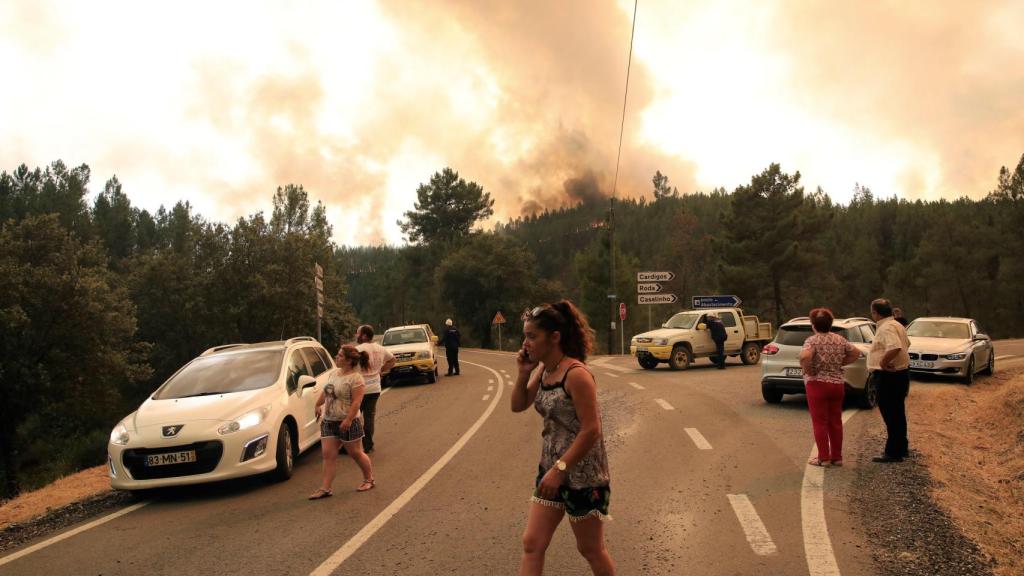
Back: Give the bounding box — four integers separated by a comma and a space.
800, 409, 857, 576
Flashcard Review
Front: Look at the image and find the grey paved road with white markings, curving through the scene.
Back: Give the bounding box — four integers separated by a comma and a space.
0, 340, 1024, 576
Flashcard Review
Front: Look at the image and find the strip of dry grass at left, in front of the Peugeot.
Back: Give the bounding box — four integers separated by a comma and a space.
0, 464, 111, 530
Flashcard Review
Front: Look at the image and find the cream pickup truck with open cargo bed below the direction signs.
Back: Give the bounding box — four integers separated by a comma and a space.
630, 307, 772, 370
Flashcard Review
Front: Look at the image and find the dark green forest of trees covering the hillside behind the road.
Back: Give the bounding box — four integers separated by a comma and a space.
0, 156, 1024, 498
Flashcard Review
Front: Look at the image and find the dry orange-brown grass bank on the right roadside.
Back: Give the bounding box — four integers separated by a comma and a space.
907, 370, 1024, 576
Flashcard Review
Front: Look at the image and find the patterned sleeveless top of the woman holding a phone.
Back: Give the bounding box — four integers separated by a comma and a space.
534, 364, 610, 490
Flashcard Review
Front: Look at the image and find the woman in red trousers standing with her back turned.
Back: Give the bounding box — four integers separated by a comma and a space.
800, 308, 860, 466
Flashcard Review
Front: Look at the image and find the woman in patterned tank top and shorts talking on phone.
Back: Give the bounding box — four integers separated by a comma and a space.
512, 300, 615, 576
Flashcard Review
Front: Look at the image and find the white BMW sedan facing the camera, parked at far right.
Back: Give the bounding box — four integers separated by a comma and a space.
906, 318, 995, 384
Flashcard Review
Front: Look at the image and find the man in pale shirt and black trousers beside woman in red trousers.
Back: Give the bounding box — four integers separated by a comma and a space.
867, 298, 910, 463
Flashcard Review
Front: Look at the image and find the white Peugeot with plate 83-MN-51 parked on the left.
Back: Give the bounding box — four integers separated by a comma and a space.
106, 336, 334, 490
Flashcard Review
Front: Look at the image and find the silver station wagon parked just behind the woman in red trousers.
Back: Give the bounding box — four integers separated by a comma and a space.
761, 317, 879, 408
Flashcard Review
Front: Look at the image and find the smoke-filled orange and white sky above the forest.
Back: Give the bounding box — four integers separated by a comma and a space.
0, 0, 1024, 245
